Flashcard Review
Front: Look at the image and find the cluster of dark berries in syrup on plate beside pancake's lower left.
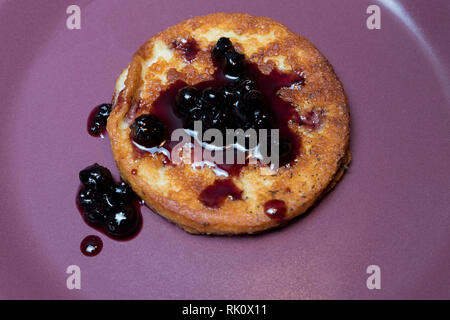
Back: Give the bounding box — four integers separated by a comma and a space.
77, 163, 141, 238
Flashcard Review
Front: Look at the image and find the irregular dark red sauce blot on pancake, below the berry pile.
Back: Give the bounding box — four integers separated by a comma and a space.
199, 179, 242, 208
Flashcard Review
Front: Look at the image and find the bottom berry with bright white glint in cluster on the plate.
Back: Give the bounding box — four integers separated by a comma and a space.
105, 205, 140, 238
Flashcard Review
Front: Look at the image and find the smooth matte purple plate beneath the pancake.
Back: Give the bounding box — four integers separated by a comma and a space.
0, 0, 450, 299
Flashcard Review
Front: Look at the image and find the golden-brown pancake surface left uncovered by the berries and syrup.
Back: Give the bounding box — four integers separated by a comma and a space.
107, 13, 350, 234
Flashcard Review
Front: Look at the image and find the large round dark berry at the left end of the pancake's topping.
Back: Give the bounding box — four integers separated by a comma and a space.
130, 114, 167, 148
